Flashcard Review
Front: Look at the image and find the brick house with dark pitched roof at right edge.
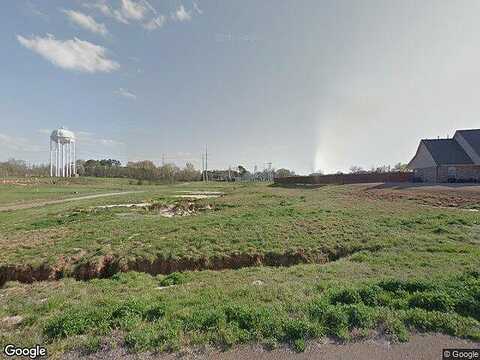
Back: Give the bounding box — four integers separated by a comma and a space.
408, 129, 480, 182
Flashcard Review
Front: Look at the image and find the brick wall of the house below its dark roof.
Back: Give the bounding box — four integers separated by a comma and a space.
415, 165, 480, 183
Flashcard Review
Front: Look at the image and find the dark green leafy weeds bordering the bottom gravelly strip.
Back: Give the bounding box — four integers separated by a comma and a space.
33, 273, 480, 351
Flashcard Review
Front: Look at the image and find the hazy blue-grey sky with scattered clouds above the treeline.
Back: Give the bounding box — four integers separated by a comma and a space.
0, 0, 480, 174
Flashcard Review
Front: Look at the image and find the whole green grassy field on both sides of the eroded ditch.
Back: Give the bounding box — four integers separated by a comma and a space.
0, 179, 480, 356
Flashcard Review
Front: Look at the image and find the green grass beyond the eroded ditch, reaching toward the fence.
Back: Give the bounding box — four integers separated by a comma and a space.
0, 180, 479, 265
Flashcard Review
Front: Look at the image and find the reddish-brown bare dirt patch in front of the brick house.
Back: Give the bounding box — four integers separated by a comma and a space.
355, 184, 480, 209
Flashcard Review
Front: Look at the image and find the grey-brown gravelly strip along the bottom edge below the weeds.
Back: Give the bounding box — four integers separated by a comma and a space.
63, 334, 480, 360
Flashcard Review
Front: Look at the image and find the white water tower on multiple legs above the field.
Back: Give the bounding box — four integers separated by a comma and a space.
50, 127, 76, 177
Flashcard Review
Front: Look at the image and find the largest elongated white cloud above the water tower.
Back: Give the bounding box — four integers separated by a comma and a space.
17, 34, 120, 73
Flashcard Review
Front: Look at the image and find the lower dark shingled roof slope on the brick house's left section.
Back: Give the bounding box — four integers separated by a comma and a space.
422, 139, 470, 165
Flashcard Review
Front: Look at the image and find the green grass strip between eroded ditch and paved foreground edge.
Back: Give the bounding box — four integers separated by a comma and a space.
0, 261, 480, 354
